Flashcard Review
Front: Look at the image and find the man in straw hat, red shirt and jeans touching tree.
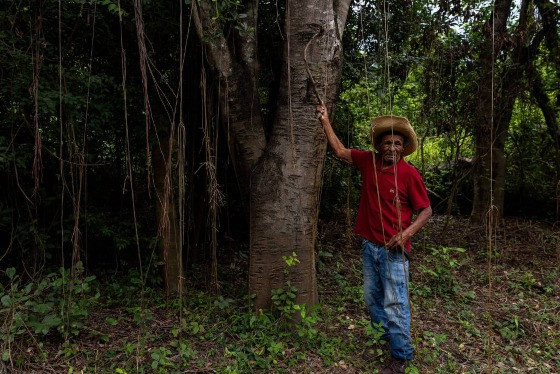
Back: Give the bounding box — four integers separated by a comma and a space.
317, 105, 432, 374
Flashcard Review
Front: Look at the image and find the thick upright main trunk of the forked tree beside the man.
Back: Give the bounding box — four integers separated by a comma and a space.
249, 0, 342, 310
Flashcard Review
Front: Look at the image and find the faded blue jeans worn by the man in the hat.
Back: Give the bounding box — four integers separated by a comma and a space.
362, 240, 414, 360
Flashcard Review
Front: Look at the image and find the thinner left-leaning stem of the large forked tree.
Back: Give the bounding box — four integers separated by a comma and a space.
192, 0, 266, 205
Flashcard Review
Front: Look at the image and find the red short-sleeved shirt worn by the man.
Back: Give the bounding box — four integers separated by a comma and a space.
351, 149, 430, 252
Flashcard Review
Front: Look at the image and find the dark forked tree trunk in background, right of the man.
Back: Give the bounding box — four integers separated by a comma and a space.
471, 0, 544, 223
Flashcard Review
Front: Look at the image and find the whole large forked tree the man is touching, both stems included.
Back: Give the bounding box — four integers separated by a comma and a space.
193, 0, 350, 309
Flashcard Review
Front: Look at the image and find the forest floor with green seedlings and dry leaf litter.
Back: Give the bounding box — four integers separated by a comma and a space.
0, 216, 560, 373
